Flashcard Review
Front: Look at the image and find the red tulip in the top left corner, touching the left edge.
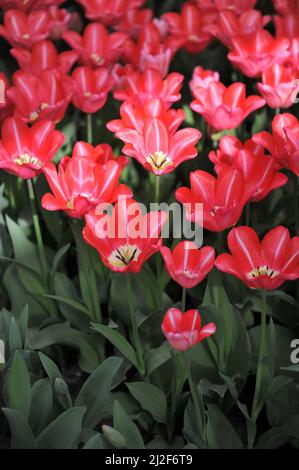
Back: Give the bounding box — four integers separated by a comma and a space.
0, 10, 50, 49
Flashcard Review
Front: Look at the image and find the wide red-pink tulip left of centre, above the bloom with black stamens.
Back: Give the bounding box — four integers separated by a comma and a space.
42, 156, 132, 218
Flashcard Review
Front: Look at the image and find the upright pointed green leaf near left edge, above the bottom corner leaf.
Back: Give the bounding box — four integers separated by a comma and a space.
5, 351, 31, 420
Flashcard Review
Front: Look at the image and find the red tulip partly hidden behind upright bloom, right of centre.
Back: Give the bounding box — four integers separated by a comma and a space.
209, 136, 288, 202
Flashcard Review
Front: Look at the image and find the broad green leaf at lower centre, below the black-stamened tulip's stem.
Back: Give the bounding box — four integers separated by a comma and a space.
126, 382, 167, 423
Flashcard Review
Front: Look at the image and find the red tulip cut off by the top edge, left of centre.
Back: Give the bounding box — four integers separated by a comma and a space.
78, 0, 145, 26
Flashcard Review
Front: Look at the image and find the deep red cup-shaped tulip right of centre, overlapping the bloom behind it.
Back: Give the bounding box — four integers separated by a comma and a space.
175, 169, 248, 232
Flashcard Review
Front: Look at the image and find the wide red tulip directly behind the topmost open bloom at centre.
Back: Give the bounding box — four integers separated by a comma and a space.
113, 69, 184, 108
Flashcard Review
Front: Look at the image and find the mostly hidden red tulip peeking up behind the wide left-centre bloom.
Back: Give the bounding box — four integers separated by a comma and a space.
72, 141, 128, 168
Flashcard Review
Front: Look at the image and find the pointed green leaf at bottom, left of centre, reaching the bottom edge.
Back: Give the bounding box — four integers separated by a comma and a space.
113, 400, 144, 449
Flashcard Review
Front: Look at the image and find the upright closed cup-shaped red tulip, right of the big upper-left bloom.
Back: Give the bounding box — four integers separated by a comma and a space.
72, 67, 113, 113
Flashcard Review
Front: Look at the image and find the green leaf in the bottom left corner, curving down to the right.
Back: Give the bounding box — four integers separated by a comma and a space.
2, 408, 36, 449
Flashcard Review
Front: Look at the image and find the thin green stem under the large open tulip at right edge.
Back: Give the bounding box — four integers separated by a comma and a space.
251, 290, 267, 422
